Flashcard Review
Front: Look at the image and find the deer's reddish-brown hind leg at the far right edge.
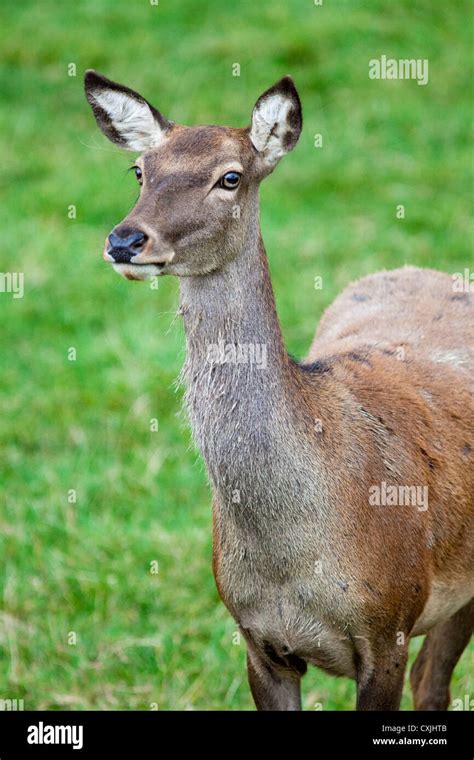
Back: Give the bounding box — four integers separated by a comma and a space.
410, 599, 474, 710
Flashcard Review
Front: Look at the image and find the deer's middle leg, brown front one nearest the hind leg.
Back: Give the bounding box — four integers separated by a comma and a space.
357, 644, 407, 710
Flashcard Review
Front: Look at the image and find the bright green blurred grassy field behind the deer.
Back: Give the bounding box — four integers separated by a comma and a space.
0, 0, 474, 710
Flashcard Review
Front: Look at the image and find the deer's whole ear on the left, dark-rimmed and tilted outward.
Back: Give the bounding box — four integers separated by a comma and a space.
84, 69, 172, 152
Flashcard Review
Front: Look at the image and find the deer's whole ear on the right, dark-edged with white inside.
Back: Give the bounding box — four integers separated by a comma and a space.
250, 76, 303, 168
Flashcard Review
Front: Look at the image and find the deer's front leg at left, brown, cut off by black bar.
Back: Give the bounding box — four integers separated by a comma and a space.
247, 645, 301, 711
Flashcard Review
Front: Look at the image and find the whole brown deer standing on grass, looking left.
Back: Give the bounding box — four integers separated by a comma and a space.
85, 70, 474, 711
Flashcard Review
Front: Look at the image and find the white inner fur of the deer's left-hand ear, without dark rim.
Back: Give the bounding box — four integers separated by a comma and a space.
93, 90, 164, 151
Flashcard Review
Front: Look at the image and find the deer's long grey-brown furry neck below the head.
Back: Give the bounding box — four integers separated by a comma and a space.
180, 199, 295, 497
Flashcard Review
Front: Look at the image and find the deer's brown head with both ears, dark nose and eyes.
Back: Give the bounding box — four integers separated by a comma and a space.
85, 70, 302, 280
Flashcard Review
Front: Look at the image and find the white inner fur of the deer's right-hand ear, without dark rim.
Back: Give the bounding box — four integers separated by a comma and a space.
250, 93, 294, 164
